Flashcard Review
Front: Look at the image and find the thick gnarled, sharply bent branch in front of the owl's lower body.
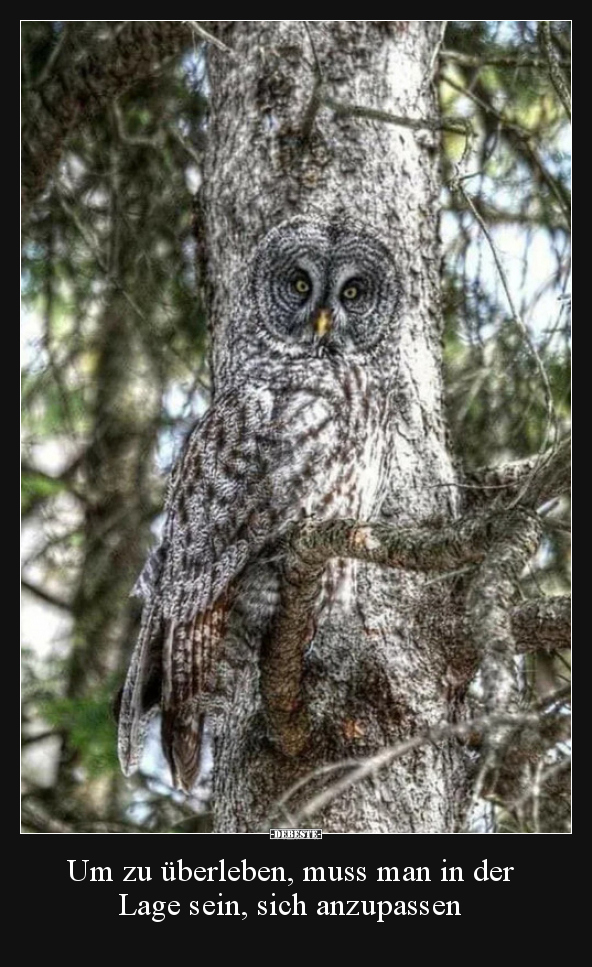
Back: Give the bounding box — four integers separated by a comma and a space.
261, 506, 569, 796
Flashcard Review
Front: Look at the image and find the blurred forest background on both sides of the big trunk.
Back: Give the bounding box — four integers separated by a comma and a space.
22, 20, 571, 832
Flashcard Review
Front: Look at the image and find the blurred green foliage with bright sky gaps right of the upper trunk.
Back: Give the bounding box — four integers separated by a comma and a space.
440, 21, 570, 480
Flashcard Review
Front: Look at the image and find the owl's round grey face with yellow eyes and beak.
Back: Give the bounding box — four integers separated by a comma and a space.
247, 218, 400, 355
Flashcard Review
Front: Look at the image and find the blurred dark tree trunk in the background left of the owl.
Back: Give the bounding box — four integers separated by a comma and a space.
55, 293, 160, 817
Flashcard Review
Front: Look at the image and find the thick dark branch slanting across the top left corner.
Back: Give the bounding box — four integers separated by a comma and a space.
22, 20, 194, 215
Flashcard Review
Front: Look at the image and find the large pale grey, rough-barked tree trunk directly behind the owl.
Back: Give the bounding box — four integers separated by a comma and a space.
203, 20, 475, 833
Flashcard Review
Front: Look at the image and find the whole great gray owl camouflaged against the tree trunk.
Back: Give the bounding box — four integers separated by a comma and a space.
119, 218, 399, 790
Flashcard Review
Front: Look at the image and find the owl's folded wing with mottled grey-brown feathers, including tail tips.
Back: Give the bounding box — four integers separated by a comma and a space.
119, 387, 337, 789
